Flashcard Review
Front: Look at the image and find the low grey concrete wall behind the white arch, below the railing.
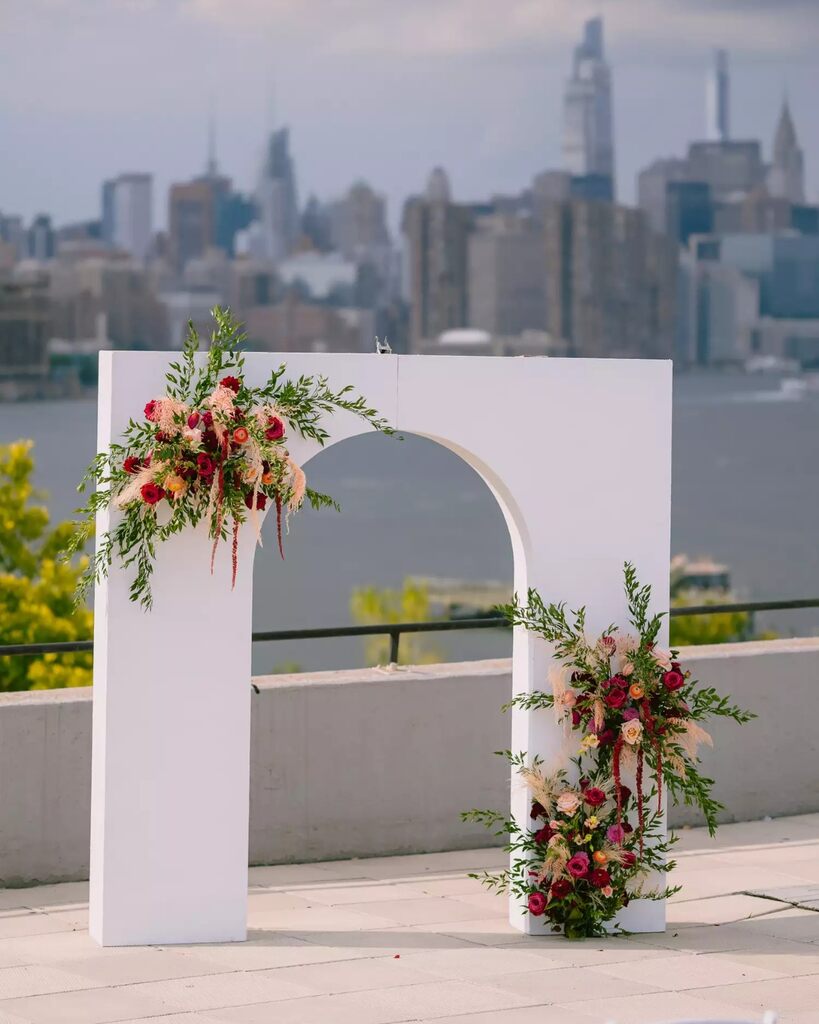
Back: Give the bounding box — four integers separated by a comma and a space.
0, 639, 819, 886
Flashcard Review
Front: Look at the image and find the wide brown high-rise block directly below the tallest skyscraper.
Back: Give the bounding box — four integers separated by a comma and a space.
545, 200, 678, 357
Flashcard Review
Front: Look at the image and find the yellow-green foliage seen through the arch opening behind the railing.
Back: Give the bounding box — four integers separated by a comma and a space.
350, 580, 443, 665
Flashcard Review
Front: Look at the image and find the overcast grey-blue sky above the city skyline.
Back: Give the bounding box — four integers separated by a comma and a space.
0, 0, 819, 230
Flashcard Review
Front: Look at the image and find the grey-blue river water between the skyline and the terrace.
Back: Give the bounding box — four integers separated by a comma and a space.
0, 374, 819, 673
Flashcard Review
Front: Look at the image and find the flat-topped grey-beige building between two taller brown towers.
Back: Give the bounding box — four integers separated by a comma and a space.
467, 214, 547, 336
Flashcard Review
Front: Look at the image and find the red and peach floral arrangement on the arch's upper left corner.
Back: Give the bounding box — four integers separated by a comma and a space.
66, 307, 393, 608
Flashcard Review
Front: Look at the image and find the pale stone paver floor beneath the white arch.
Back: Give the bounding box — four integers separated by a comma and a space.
0, 815, 819, 1024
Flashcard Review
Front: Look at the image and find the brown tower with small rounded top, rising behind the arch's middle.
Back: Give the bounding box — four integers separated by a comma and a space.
402, 167, 473, 350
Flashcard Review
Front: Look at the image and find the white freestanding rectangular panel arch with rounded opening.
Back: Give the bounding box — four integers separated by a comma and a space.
90, 352, 672, 945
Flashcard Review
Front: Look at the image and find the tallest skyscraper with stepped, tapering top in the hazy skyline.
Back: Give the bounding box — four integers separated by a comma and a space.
563, 17, 614, 196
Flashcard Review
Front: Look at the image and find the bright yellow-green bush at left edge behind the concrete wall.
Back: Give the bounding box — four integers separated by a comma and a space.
0, 441, 93, 690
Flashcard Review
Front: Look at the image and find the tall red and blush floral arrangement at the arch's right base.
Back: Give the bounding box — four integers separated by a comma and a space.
464, 563, 755, 938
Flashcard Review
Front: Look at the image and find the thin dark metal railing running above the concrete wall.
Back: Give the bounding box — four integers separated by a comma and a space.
0, 597, 819, 663
